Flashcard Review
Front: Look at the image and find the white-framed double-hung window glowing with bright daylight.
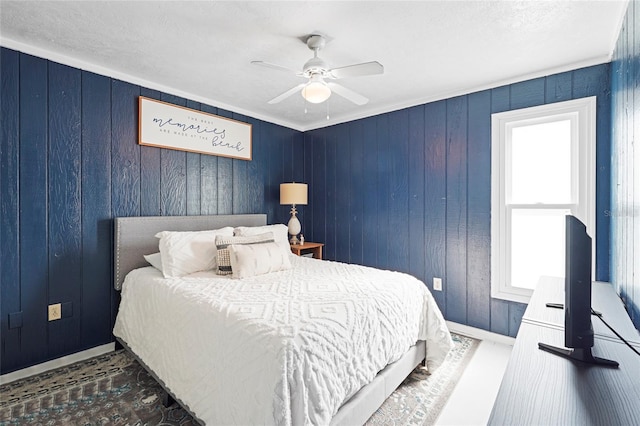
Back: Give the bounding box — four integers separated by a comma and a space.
491, 97, 596, 303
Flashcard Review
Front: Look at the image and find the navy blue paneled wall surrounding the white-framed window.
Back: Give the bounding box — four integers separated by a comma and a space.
303, 64, 611, 336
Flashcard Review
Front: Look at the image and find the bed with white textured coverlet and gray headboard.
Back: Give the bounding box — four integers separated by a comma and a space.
114, 214, 452, 425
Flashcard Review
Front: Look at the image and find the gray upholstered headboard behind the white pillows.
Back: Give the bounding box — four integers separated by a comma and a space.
113, 214, 267, 290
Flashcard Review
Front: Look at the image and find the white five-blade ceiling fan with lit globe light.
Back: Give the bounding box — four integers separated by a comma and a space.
251, 34, 384, 105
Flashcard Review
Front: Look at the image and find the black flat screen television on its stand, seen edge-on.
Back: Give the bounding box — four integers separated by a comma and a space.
538, 215, 618, 368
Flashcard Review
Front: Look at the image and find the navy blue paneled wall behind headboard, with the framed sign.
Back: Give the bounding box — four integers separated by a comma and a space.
0, 48, 303, 373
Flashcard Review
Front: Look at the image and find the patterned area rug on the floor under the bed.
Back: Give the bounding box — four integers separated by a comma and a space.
0, 334, 479, 426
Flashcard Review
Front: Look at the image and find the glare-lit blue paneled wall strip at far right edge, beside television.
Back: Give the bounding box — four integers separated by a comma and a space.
610, 1, 640, 330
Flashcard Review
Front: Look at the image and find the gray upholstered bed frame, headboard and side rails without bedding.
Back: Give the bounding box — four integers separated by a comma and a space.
114, 214, 425, 425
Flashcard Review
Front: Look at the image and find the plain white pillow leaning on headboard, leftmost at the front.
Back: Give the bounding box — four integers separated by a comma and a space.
156, 226, 233, 278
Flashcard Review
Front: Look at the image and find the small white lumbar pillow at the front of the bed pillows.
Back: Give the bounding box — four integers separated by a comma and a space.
229, 242, 291, 278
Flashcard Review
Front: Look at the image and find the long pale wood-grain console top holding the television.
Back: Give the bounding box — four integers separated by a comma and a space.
488, 278, 640, 426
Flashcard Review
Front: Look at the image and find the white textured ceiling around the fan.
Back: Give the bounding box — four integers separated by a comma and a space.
0, 0, 627, 130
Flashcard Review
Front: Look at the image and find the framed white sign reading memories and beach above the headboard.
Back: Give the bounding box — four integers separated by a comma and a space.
138, 96, 251, 160
